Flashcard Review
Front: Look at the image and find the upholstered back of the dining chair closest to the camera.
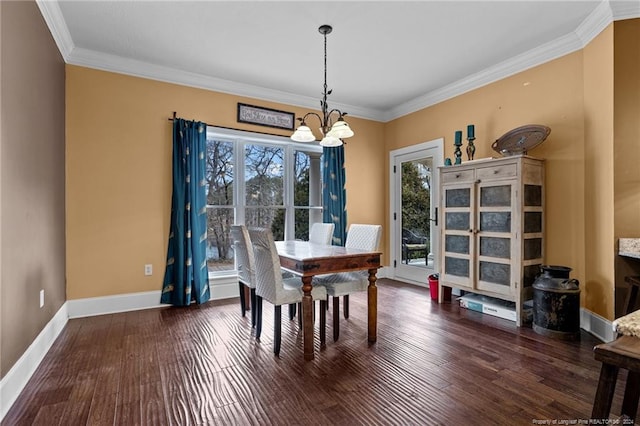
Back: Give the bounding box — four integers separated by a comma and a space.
249, 228, 284, 303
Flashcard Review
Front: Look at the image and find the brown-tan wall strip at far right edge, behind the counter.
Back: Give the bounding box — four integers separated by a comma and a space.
613, 19, 640, 317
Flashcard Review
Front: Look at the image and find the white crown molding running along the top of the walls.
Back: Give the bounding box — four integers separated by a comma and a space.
41, 0, 640, 122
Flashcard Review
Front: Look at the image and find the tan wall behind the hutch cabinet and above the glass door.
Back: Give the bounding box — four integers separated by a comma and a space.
385, 52, 585, 300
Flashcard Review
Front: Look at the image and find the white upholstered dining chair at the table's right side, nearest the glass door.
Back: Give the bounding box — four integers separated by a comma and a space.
313, 223, 382, 341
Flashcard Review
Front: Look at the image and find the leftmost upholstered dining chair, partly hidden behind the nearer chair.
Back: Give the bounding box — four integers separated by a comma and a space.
230, 225, 256, 327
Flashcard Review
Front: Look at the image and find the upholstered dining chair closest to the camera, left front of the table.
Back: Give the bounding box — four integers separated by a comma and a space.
249, 228, 327, 355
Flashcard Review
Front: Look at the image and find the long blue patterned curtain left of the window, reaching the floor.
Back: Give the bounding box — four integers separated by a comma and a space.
161, 118, 209, 306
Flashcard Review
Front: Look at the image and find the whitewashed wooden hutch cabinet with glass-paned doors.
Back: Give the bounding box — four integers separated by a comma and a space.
438, 155, 544, 326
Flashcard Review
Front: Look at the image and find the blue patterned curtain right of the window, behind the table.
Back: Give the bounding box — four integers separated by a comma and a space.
322, 145, 347, 246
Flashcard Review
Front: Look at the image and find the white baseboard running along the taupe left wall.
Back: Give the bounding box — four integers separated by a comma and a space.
0, 303, 69, 421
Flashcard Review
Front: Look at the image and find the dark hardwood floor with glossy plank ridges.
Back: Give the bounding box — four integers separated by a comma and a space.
2, 279, 624, 426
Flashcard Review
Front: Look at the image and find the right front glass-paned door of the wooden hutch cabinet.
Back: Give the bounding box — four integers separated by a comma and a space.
475, 182, 515, 294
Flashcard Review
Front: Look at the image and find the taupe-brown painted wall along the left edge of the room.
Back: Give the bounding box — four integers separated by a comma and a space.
0, 2, 66, 377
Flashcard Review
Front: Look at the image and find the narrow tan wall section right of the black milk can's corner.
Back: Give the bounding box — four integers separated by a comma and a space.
582, 25, 615, 319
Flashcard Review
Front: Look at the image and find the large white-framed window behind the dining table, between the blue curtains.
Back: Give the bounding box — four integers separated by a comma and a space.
206, 128, 322, 276
